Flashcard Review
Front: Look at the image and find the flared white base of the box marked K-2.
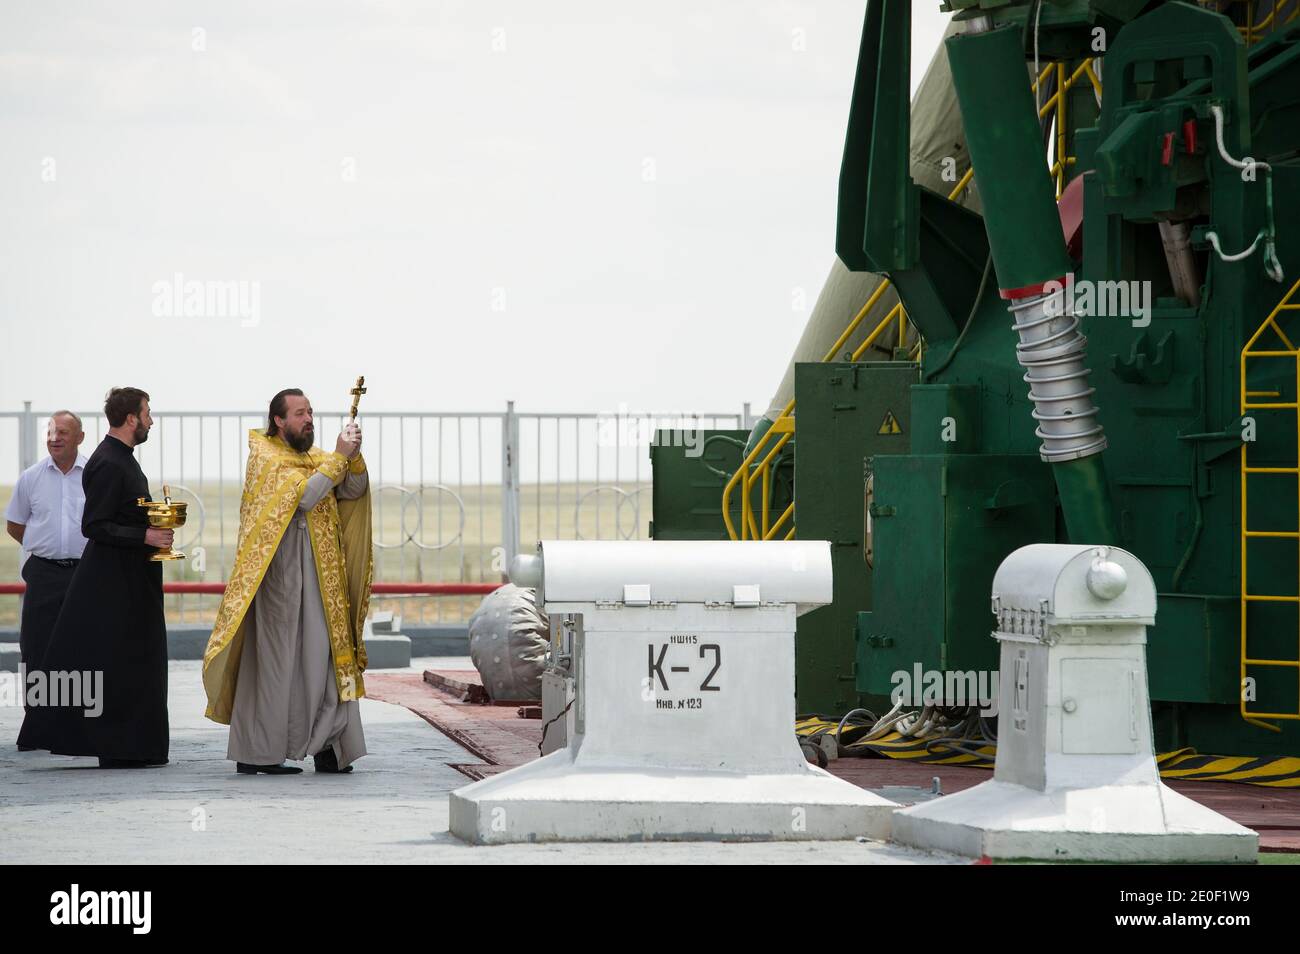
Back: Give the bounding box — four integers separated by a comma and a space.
450, 749, 898, 845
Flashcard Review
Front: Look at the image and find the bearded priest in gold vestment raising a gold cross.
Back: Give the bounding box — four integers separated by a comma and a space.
203, 389, 373, 775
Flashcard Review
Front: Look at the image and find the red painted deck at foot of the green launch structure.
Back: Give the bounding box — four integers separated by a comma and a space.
365, 669, 1300, 851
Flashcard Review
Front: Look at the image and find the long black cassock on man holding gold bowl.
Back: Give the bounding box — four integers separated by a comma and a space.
18, 435, 168, 762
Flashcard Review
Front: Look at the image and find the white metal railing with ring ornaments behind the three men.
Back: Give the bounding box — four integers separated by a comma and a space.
0, 402, 751, 625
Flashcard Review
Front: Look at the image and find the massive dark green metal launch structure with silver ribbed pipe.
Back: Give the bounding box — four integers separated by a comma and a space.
655, 0, 1300, 755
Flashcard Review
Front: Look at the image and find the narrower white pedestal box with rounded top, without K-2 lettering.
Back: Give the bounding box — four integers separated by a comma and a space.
893, 543, 1258, 862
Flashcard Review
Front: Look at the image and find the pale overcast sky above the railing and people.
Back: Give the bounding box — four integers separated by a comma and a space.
0, 0, 943, 412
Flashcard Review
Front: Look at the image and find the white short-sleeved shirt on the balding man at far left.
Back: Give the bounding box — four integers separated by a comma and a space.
4, 454, 86, 560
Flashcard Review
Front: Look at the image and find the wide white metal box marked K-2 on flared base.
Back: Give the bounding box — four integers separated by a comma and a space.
451, 541, 897, 844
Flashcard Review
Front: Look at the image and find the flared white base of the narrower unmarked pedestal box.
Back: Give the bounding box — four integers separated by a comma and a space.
892, 780, 1260, 863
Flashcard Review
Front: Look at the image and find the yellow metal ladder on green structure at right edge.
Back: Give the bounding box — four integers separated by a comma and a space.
1240, 281, 1300, 732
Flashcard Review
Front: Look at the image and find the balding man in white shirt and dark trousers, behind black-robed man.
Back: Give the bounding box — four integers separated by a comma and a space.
4, 411, 86, 738
